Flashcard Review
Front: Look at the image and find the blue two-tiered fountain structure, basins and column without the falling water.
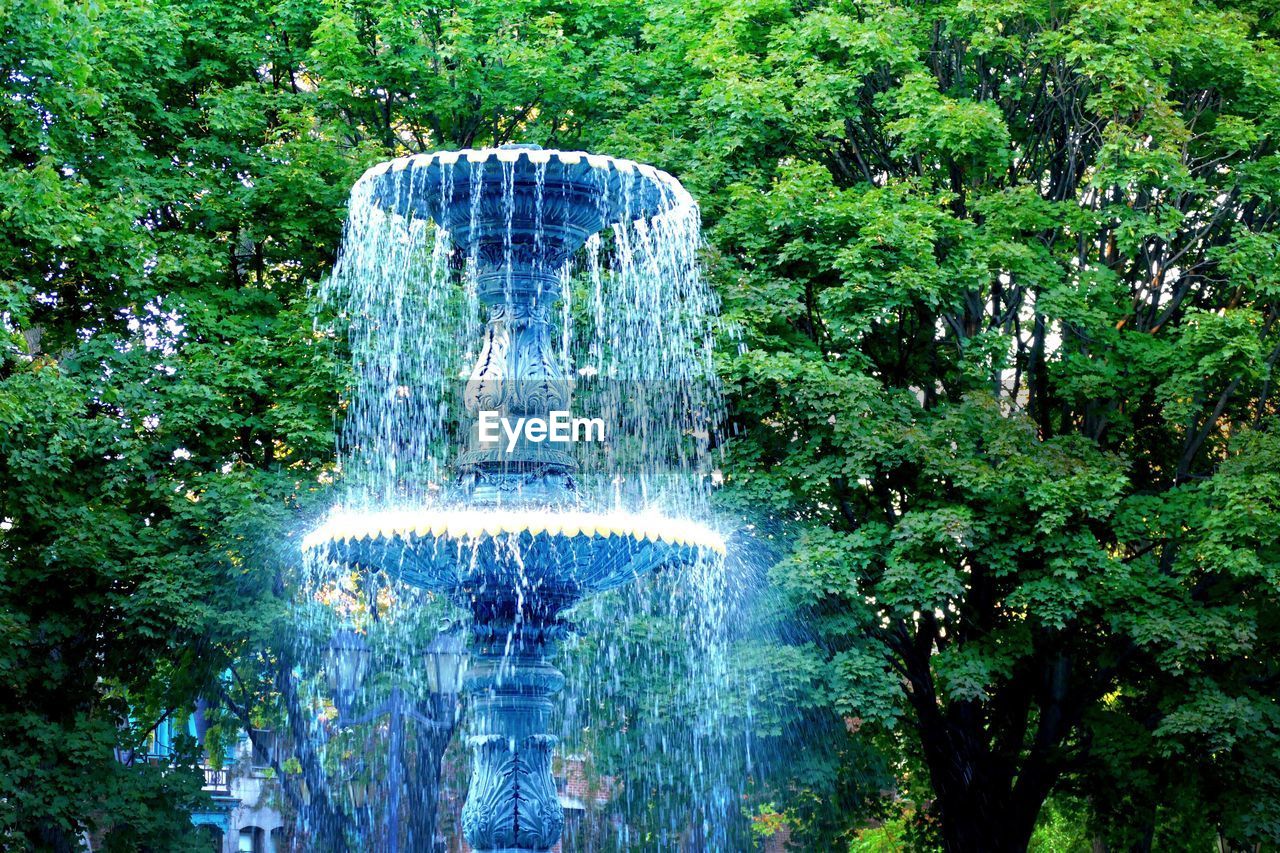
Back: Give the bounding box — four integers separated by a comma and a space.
306, 146, 723, 850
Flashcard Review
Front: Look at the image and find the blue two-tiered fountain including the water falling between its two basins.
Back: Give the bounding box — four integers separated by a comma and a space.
296, 146, 724, 850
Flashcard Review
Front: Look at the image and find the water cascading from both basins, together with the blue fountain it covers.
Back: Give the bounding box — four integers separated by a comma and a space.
296, 146, 733, 850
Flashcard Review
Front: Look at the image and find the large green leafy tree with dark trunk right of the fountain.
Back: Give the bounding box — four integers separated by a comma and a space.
640, 3, 1280, 850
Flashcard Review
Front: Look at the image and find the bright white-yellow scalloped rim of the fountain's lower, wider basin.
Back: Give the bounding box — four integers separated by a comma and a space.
294, 510, 726, 555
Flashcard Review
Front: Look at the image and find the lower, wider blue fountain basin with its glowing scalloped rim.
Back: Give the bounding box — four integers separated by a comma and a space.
302, 508, 724, 596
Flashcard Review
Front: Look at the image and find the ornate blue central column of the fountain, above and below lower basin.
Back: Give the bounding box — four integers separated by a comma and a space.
456, 242, 577, 852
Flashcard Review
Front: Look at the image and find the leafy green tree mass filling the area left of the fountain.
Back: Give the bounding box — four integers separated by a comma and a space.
0, 3, 353, 850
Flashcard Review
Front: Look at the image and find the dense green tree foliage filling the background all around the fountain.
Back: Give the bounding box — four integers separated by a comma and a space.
0, 0, 1280, 850
